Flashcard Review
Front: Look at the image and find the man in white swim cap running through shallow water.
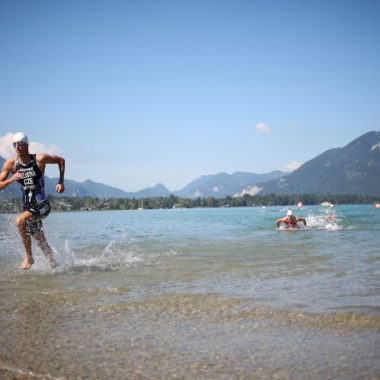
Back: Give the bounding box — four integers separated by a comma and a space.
0, 132, 65, 269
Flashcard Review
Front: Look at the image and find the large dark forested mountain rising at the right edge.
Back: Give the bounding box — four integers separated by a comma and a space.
258, 131, 380, 195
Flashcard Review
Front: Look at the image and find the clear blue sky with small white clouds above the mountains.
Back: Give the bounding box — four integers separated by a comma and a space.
0, 0, 380, 191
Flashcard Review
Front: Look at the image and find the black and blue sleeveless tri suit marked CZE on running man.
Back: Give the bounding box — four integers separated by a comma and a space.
15, 154, 50, 235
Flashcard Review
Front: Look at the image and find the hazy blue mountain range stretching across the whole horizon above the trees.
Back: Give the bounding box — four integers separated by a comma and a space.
0, 131, 380, 199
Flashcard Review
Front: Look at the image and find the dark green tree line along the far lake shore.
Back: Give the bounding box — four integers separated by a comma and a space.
0, 194, 380, 212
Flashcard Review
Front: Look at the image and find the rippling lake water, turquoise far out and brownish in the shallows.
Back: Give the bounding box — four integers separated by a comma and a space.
0, 205, 380, 379
